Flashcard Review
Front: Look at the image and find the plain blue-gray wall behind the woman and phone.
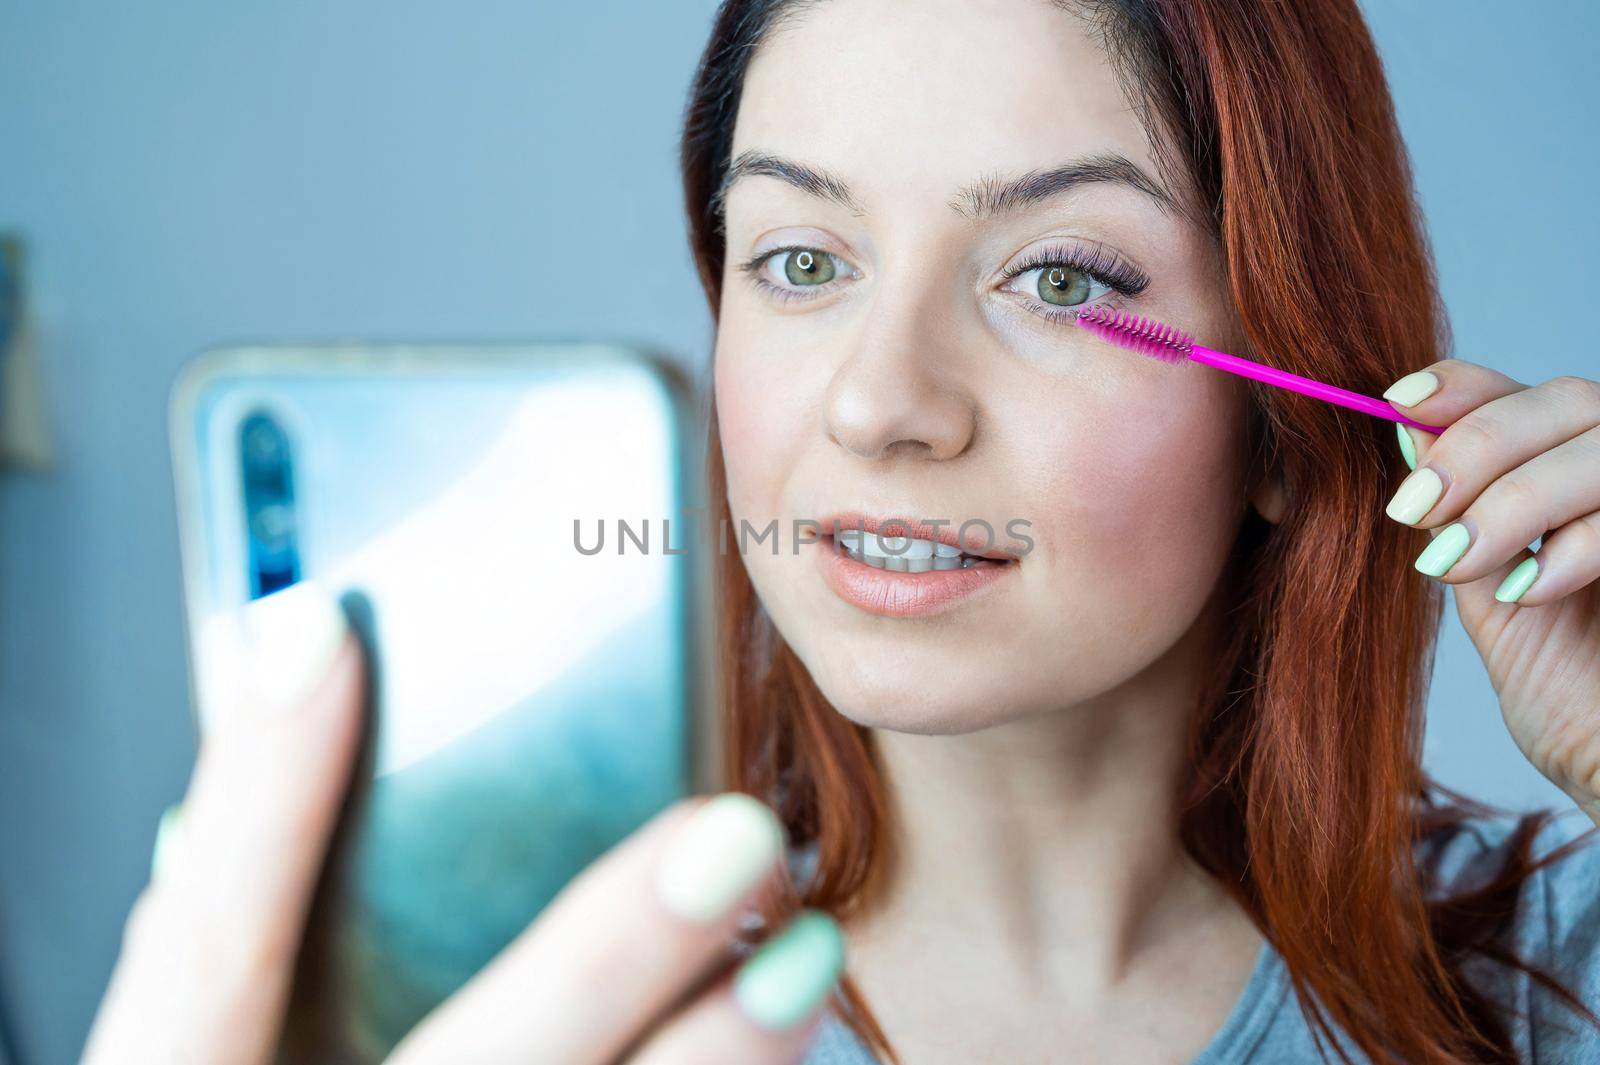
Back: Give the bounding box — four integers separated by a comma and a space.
0, 0, 1600, 1065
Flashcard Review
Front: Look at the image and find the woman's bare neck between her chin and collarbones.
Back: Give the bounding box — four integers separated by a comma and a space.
851, 591, 1248, 1001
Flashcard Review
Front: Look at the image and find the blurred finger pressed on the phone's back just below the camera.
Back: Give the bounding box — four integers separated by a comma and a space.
86, 584, 362, 1063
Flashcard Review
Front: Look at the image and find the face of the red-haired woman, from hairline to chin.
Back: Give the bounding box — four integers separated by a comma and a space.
715, 0, 1273, 732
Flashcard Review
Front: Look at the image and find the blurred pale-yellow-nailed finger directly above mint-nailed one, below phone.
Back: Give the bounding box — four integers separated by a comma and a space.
389, 792, 786, 1065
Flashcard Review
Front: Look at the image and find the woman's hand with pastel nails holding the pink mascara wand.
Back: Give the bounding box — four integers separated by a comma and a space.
1384, 358, 1600, 824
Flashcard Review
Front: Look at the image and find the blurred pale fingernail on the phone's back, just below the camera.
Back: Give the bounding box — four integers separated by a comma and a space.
243, 580, 346, 710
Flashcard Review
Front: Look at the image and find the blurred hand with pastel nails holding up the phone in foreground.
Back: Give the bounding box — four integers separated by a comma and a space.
83, 584, 843, 1065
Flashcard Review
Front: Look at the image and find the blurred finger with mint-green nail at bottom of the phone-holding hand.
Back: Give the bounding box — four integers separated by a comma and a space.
627, 910, 845, 1065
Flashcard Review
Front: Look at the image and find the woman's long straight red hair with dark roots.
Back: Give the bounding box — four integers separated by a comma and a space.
682, 0, 1594, 1065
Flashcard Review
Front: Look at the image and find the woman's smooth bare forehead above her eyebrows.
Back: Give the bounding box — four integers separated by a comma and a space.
733, 0, 1155, 211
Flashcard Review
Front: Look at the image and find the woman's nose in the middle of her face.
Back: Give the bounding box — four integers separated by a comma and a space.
822, 294, 978, 459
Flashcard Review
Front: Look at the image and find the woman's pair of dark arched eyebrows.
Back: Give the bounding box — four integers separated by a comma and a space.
712, 149, 1178, 222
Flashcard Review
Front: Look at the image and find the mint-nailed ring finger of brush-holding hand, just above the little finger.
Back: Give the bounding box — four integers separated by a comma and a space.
1416, 429, 1600, 584
